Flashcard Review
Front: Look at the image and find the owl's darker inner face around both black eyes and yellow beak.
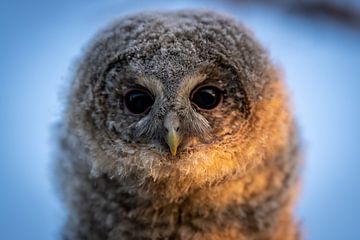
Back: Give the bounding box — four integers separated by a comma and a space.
103, 63, 249, 158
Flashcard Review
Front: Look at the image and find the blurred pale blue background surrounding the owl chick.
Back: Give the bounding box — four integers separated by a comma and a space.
0, 0, 360, 240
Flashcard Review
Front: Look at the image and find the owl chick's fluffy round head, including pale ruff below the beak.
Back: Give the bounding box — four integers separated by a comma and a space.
67, 10, 291, 199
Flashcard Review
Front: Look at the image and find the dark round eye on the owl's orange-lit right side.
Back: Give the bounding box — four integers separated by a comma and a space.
190, 86, 222, 110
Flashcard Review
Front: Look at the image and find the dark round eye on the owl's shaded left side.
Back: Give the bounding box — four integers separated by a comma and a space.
124, 89, 154, 114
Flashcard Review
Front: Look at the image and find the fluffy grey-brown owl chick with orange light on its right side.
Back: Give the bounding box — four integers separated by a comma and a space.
56, 10, 300, 240
